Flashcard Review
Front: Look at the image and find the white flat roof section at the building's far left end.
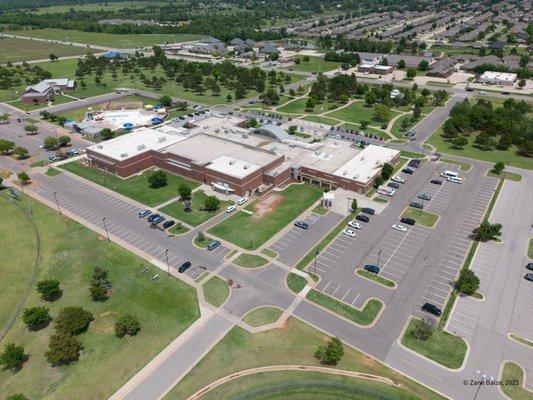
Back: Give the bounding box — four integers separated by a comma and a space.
88, 128, 187, 161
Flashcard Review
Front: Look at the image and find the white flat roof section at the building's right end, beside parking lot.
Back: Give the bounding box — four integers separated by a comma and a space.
333, 144, 400, 183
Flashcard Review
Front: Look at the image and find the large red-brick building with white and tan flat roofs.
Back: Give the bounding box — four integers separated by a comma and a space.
87, 115, 400, 196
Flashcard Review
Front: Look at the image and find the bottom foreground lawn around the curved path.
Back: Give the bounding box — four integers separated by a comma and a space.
166, 318, 442, 400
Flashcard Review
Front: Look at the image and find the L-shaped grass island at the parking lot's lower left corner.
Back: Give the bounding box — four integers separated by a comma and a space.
306, 289, 383, 325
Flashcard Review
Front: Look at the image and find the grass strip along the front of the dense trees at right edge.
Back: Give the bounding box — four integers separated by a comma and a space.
427, 128, 533, 169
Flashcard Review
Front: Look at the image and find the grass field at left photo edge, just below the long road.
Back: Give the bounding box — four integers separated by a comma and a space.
0, 37, 87, 63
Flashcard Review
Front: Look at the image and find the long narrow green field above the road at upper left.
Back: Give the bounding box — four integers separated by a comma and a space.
7, 28, 202, 49
